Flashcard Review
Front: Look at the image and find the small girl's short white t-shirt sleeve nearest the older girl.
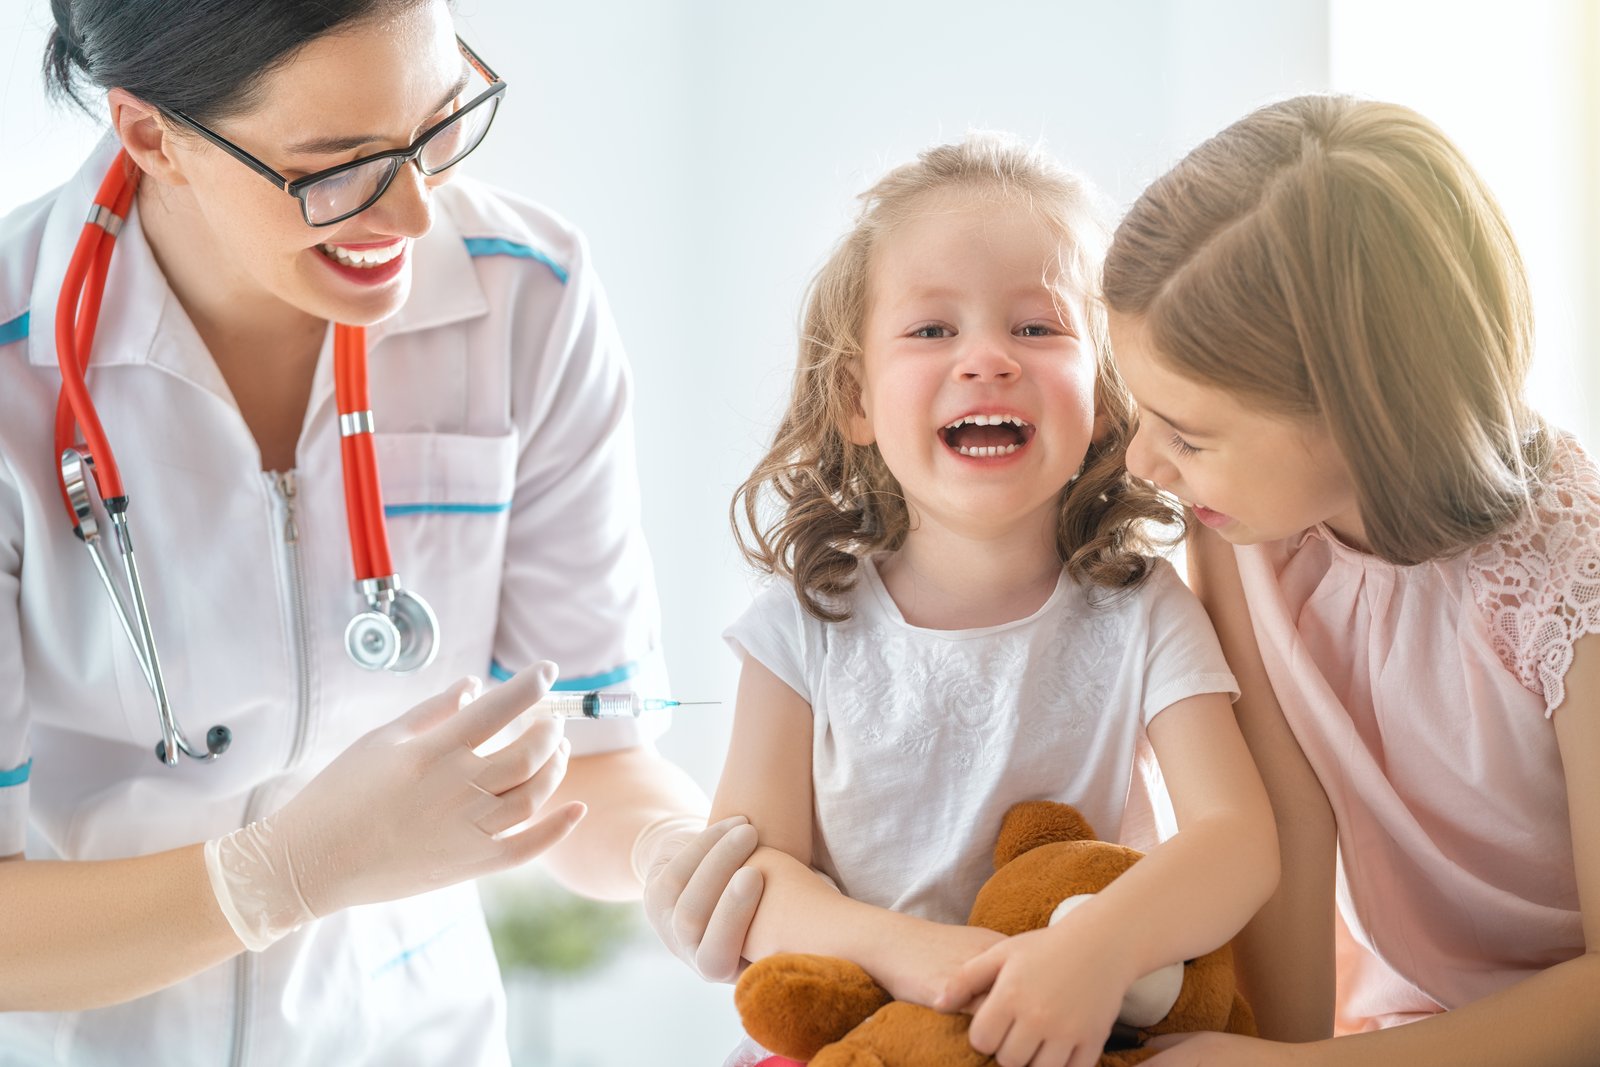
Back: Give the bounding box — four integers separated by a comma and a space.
1142, 560, 1238, 726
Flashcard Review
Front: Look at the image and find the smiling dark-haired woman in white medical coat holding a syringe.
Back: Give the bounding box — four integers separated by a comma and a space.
0, 0, 760, 1065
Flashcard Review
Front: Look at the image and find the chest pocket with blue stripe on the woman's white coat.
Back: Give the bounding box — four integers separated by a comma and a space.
373, 434, 518, 673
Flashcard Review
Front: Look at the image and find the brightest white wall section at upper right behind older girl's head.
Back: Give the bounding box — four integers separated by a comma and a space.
1328, 0, 1600, 443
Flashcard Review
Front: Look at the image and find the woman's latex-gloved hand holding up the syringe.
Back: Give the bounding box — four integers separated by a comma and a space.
205, 662, 586, 950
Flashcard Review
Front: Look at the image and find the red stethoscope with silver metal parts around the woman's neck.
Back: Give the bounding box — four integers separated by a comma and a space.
56, 152, 438, 766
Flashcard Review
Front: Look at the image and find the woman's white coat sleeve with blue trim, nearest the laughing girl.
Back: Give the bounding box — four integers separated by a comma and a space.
490, 234, 670, 753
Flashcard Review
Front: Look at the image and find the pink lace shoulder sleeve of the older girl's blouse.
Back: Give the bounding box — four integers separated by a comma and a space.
1469, 438, 1600, 715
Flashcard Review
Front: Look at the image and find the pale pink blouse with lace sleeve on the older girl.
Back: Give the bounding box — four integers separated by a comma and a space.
1235, 438, 1600, 1032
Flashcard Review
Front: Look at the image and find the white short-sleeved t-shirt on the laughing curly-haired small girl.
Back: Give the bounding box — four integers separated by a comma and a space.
723, 560, 1238, 923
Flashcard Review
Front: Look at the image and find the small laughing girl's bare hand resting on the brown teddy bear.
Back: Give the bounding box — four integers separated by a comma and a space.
933, 923, 1131, 1067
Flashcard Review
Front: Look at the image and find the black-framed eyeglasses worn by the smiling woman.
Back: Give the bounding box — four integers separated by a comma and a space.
165, 37, 506, 226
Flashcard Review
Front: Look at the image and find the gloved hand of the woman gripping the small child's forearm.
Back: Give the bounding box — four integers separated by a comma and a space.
634, 816, 763, 982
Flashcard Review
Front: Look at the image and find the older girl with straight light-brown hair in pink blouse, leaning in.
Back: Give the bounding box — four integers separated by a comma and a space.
1106, 96, 1600, 1067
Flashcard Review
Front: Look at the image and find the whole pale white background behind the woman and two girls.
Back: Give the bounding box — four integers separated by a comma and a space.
0, 0, 1600, 1067
